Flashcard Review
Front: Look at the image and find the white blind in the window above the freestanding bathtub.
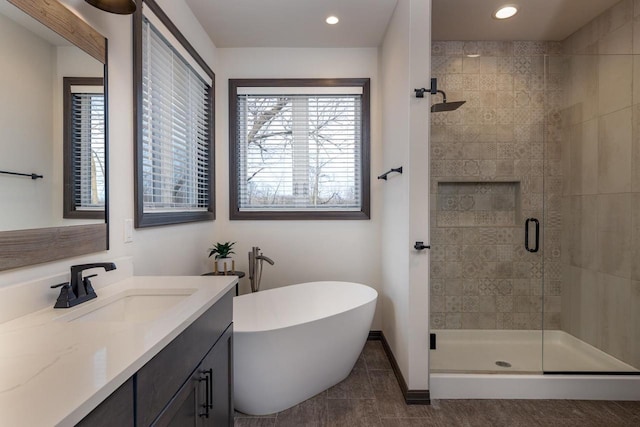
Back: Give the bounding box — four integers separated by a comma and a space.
236, 87, 362, 211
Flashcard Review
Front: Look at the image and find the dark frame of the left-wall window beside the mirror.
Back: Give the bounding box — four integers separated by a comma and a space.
133, 0, 216, 228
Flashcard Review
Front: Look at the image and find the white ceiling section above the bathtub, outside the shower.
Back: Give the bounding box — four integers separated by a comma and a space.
186, 0, 397, 47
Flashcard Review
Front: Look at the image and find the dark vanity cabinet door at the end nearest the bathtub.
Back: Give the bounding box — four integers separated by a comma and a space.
201, 324, 233, 427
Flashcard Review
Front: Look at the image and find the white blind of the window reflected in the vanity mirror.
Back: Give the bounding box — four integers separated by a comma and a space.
71, 90, 105, 211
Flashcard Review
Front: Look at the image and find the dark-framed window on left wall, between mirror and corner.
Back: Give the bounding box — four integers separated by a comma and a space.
135, 0, 214, 227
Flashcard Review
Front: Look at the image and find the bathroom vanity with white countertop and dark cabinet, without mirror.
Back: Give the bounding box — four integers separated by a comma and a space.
0, 276, 237, 427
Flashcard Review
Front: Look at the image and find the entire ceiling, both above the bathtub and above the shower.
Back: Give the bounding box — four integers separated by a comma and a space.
186, 0, 620, 48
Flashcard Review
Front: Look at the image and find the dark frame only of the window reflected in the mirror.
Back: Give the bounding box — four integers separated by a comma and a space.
62, 77, 108, 220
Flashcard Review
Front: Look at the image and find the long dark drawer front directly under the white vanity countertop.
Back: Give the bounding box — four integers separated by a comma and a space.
136, 290, 234, 426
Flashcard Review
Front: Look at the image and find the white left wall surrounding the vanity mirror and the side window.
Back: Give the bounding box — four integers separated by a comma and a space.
0, 0, 219, 290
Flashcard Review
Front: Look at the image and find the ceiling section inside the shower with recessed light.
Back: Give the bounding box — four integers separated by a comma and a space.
431, 0, 620, 40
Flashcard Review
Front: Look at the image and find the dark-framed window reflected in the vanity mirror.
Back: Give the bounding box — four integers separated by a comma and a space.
63, 77, 106, 219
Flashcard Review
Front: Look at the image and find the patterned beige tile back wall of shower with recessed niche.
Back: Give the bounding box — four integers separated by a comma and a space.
430, 41, 561, 329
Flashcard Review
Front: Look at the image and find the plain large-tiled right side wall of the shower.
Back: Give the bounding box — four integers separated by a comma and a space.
557, 0, 640, 368
